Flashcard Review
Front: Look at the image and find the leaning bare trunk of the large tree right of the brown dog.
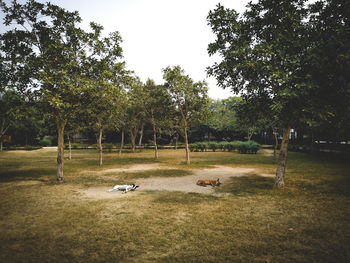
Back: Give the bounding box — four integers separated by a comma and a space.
275, 126, 290, 188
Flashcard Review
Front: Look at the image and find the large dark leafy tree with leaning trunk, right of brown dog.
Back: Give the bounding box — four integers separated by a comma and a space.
208, 0, 349, 187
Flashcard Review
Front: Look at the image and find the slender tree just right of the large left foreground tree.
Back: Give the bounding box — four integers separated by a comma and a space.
85, 23, 126, 166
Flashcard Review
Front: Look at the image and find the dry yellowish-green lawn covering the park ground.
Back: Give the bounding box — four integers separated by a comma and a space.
0, 147, 350, 262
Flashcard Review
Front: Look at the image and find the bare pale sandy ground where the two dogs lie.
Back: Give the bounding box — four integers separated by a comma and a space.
79, 164, 274, 199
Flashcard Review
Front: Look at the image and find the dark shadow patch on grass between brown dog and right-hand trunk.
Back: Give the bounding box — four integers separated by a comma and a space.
217, 175, 274, 195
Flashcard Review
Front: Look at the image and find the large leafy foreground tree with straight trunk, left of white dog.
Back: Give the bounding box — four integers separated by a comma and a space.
1, 0, 93, 182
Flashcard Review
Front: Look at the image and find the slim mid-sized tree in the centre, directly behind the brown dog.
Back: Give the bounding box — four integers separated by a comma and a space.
163, 66, 209, 164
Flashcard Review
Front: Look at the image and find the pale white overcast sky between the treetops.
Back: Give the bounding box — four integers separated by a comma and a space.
1, 0, 248, 99
